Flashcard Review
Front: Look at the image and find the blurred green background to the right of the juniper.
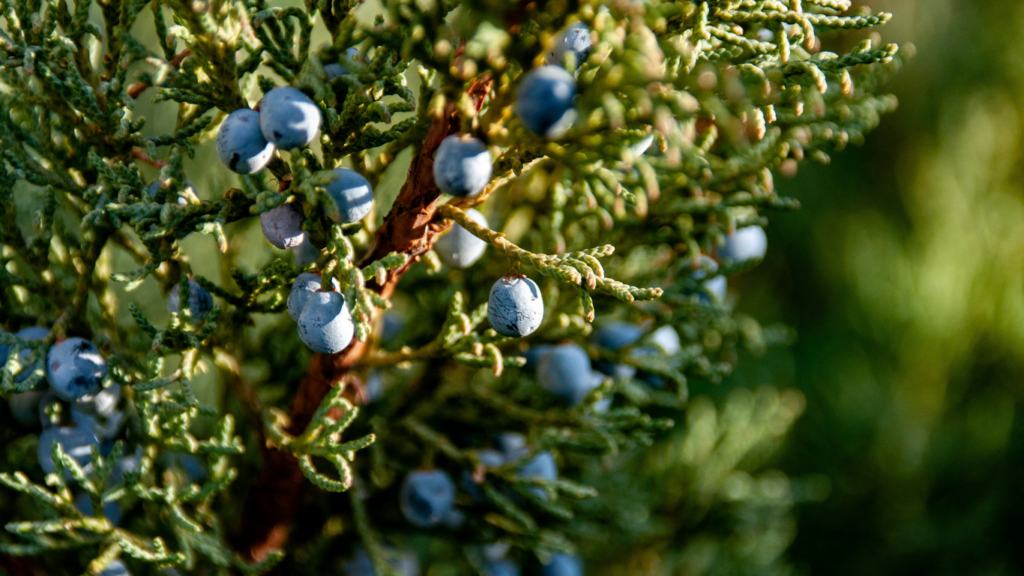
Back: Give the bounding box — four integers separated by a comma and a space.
729, 0, 1024, 576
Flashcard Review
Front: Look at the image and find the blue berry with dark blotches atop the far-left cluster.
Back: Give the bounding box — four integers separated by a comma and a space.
46, 338, 106, 402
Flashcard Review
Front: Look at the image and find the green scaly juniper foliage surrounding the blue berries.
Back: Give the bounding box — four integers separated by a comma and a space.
0, 0, 898, 574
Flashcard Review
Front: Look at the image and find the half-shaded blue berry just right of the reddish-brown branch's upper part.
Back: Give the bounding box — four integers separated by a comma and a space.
434, 134, 494, 198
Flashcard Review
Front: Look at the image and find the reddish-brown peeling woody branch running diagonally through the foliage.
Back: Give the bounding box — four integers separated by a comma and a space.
236, 77, 493, 562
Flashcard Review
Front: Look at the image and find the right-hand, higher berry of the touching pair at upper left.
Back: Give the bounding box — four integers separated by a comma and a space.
259, 86, 321, 150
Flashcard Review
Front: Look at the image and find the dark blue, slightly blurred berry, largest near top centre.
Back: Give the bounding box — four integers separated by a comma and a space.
515, 65, 577, 138
